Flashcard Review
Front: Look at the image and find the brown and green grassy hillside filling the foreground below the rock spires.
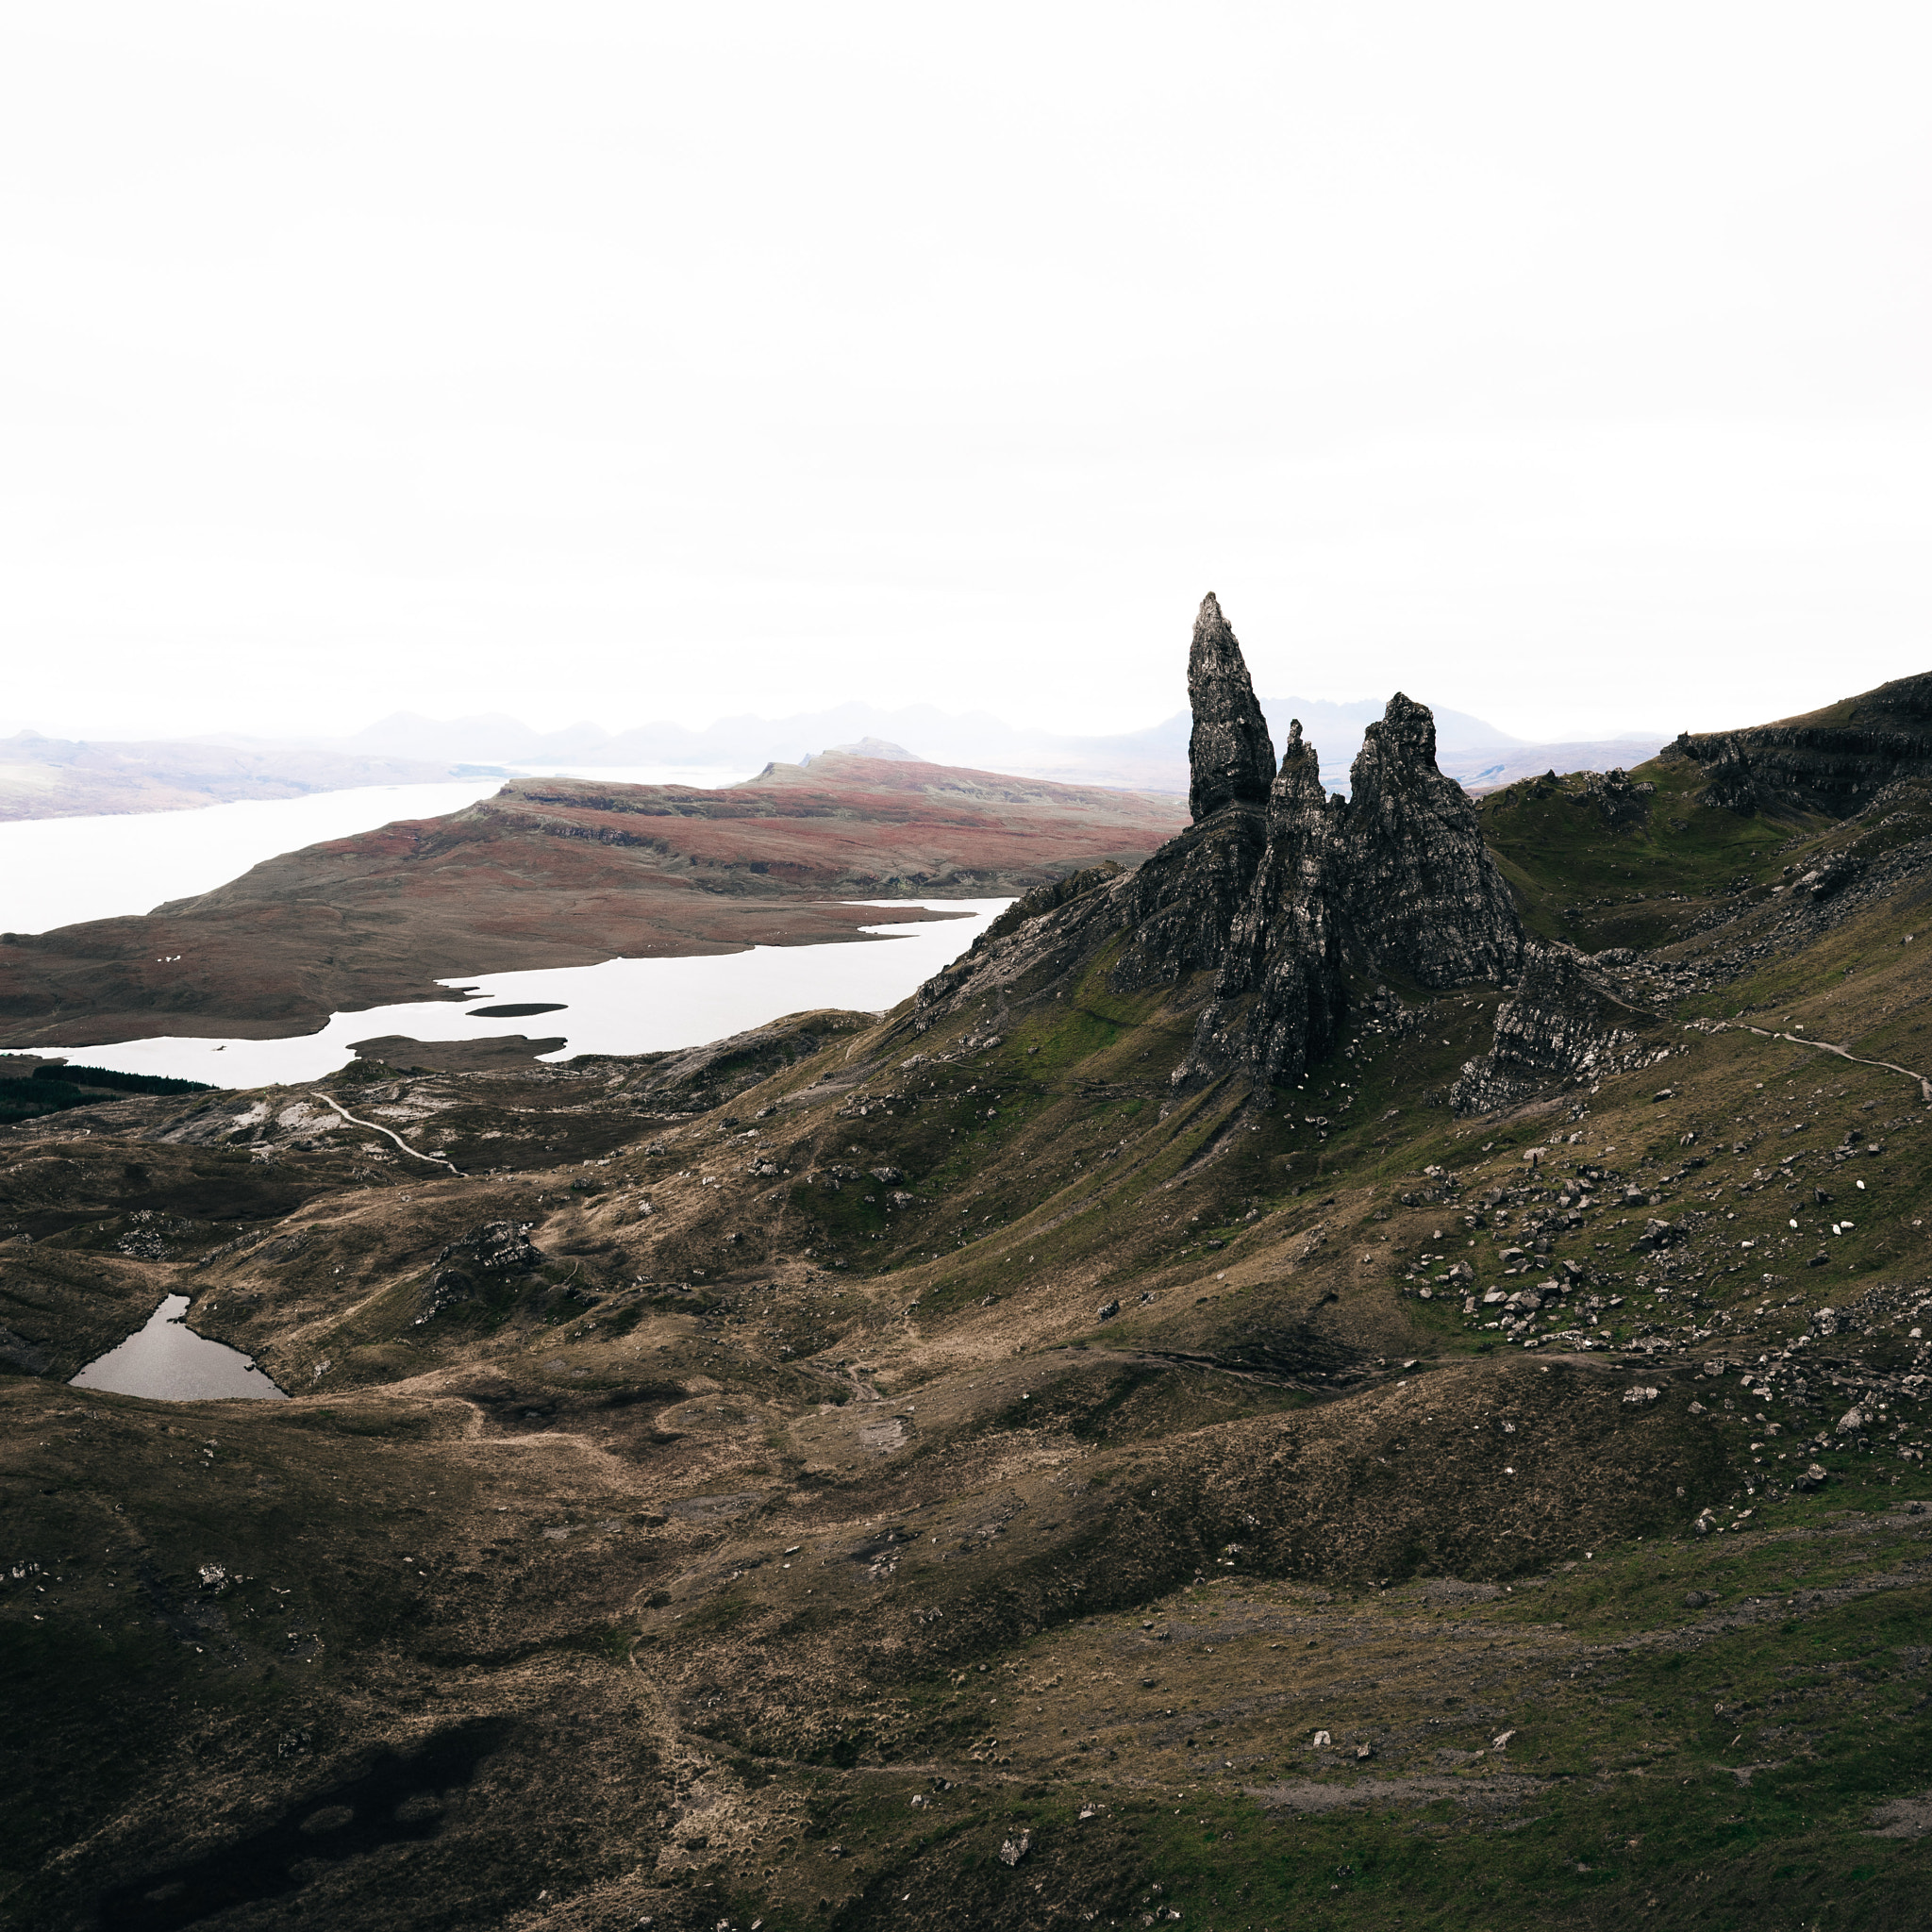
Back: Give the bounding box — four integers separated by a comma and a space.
0, 758, 1932, 1932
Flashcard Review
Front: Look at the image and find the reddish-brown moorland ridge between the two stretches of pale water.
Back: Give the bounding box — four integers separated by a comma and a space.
0, 754, 1186, 1047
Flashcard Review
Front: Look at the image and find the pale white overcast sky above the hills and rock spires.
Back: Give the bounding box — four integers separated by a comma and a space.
0, 0, 1932, 736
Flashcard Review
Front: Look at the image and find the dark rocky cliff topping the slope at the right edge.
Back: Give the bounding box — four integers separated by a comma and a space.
1663, 673, 1932, 819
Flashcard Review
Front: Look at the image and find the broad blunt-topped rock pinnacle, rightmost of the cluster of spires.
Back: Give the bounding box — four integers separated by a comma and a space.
1337, 691, 1523, 988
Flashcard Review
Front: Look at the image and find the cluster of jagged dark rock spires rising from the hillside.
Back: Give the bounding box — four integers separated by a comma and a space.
916, 595, 1523, 1088
